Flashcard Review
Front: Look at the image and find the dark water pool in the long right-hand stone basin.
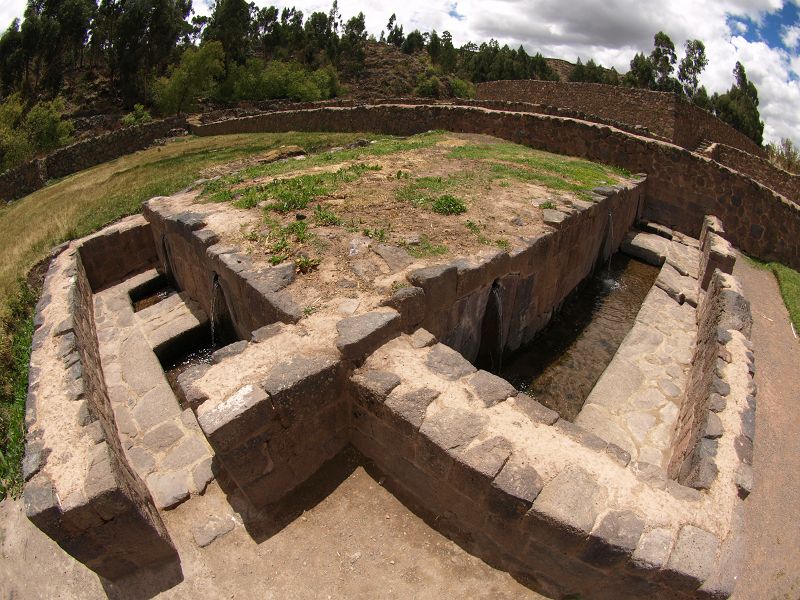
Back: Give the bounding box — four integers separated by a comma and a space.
498, 254, 658, 421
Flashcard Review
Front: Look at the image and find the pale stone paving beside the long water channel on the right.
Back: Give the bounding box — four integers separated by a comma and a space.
575, 232, 700, 467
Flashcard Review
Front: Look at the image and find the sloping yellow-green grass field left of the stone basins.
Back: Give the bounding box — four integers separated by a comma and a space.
0, 133, 372, 498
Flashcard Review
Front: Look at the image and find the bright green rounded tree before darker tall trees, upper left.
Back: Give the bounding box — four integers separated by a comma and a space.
155, 41, 225, 115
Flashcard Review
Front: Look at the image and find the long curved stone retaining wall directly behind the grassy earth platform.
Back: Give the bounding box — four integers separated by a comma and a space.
193, 105, 800, 268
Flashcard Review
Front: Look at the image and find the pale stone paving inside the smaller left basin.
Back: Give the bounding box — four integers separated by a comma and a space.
94, 270, 213, 509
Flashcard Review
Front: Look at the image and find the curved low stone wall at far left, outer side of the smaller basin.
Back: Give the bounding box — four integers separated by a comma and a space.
23, 232, 177, 579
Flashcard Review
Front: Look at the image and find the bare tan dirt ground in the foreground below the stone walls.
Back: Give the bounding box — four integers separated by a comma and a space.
0, 452, 544, 600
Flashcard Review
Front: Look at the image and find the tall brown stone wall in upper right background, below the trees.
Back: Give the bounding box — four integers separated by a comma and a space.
478, 80, 763, 156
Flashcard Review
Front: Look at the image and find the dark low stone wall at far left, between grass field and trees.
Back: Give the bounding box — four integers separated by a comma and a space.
0, 117, 186, 202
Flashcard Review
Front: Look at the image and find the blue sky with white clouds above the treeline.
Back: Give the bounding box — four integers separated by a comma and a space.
0, 0, 800, 143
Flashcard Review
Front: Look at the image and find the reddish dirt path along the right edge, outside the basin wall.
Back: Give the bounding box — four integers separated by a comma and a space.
734, 257, 800, 600
